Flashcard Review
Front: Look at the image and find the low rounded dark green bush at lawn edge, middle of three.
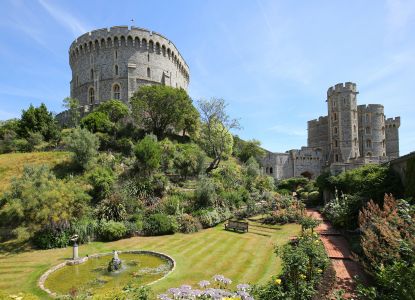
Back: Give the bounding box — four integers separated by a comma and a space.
143, 213, 179, 235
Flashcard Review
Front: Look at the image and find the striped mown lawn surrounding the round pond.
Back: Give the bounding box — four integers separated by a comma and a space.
0, 222, 300, 299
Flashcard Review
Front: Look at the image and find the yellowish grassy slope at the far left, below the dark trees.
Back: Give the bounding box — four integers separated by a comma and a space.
0, 152, 70, 195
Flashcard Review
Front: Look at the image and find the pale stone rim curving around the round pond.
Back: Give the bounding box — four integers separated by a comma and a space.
38, 250, 176, 298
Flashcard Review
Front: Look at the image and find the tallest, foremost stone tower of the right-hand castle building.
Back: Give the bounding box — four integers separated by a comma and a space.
327, 82, 360, 163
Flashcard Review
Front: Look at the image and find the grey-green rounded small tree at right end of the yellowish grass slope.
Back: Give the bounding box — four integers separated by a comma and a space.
65, 128, 99, 169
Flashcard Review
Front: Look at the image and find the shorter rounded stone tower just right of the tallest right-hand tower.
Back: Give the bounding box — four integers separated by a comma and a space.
357, 104, 386, 157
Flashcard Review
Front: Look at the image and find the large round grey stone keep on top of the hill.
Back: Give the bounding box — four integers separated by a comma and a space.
68, 26, 190, 110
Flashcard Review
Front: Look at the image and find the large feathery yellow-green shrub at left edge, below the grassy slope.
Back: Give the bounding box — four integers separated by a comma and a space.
0, 166, 90, 235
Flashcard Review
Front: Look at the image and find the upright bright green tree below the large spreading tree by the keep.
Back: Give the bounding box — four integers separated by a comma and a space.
134, 135, 161, 175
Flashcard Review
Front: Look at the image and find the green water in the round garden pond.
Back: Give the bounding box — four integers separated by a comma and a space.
45, 253, 173, 295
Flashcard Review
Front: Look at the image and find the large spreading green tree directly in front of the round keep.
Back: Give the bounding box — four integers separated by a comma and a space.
131, 85, 198, 140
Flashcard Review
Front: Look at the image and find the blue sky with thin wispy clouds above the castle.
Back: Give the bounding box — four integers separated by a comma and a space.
0, 0, 415, 155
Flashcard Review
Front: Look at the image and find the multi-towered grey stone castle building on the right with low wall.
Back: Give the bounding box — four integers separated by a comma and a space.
262, 82, 400, 179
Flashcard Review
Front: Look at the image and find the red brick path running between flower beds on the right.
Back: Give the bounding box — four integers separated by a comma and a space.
307, 209, 365, 299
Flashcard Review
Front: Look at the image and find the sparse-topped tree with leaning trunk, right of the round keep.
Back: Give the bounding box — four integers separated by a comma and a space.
198, 98, 240, 174
